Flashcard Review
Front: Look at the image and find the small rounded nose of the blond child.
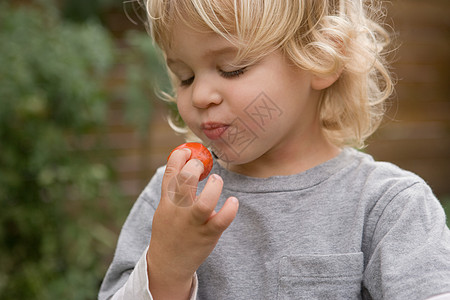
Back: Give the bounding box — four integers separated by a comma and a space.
192, 77, 222, 108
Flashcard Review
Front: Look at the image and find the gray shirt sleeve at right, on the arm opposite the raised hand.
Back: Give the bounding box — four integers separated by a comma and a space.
364, 182, 450, 300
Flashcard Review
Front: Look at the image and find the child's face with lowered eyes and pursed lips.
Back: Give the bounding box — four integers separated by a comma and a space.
166, 25, 332, 175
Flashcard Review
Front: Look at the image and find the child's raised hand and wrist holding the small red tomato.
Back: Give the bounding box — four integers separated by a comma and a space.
147, 149, 238, 299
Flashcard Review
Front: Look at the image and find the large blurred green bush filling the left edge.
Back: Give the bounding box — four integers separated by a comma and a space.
0, 1, 129, 299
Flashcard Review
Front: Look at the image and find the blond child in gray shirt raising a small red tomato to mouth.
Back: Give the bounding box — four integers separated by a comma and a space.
99, 0, 450, 299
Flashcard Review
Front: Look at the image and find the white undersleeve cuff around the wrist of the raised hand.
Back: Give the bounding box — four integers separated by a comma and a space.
112, 248, 198, 300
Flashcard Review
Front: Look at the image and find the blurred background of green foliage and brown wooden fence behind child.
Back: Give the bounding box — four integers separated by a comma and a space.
0, 0, 450, 299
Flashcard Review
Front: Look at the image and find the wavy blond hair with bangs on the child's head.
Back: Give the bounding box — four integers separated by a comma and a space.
142, 0, 393, 147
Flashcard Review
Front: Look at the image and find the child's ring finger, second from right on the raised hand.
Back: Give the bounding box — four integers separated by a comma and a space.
192, 174, 223, 224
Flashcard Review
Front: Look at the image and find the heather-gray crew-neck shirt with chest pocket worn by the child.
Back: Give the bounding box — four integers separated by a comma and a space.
99, 149, 450, 300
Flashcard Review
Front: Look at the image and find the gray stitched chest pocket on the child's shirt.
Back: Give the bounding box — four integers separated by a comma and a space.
277, 252, 364, 300
